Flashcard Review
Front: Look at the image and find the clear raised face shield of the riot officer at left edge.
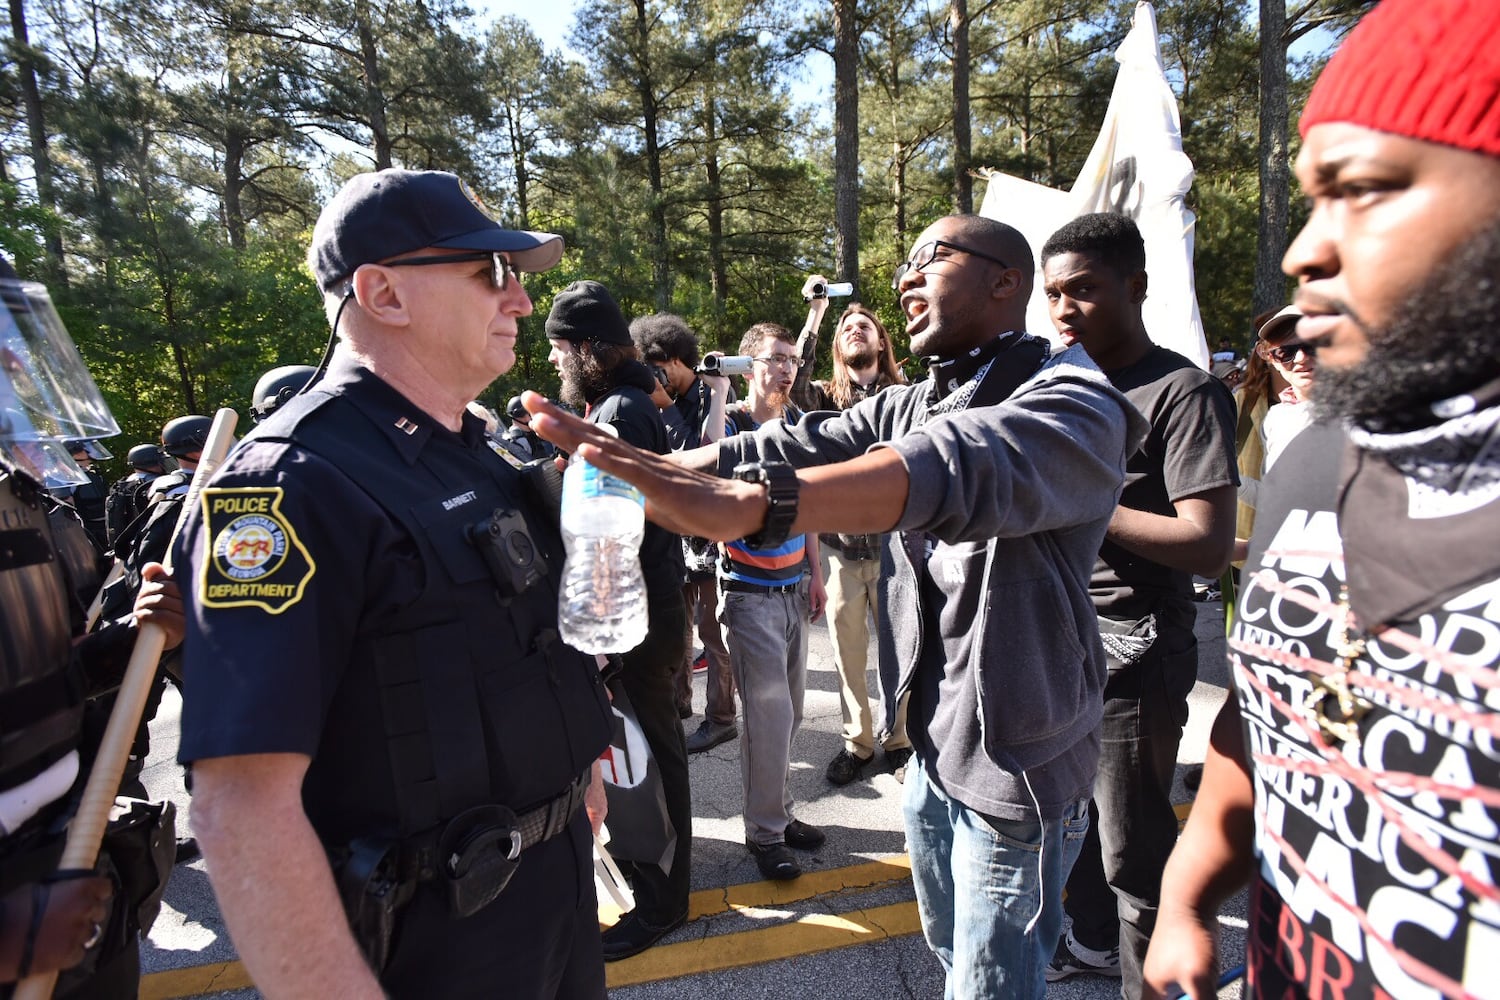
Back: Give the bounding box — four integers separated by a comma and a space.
0, 256, 120, 487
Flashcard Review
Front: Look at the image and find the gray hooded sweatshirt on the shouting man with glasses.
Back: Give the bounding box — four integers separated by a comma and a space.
719, 346, 1148, 820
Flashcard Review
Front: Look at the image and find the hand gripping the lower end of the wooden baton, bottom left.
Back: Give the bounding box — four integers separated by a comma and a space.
0, 876, 113, 982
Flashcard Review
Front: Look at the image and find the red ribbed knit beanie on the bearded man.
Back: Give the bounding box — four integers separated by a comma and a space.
1299, 0, 1500, 156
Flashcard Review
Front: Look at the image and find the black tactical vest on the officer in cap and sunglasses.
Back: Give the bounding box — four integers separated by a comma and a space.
267, 390, 612, 835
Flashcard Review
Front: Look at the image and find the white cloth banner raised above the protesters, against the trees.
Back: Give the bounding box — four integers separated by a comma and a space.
980, 0, 1209, 369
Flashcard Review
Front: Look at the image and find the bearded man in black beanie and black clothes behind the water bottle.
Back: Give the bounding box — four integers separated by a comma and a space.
546, 280, 693, 961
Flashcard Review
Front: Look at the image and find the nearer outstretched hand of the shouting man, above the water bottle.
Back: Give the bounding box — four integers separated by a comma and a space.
521, 391, 768, 541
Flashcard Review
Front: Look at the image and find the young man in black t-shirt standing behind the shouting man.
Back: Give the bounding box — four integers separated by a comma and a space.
1041, 213, 1239, 997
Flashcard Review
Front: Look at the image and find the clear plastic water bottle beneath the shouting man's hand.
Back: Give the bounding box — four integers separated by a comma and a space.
558, 446, 647, 652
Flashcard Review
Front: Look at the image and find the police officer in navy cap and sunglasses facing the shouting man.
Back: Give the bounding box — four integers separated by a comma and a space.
179, 169, 611, 997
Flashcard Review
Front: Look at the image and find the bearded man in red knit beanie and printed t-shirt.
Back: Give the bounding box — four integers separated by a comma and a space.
1145, 0, 1500, 997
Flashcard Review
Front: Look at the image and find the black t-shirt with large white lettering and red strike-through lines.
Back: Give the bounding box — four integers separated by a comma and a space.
1230, 426, 1500, 999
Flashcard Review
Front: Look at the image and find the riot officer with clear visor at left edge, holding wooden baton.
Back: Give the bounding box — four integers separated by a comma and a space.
0, 258, 182, 997
